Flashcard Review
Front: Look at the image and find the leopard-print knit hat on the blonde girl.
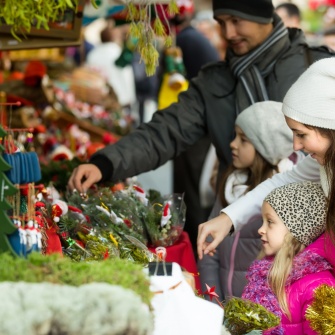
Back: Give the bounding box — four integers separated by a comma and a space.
264, 181, 327, 246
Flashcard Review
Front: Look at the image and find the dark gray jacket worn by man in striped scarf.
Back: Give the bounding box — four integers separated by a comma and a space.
90, 29, 335, 186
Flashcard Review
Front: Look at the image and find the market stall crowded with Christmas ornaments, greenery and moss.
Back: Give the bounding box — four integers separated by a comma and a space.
0, 0, 308, 335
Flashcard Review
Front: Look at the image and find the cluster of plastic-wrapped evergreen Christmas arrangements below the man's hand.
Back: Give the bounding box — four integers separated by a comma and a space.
50, 182, 186, 265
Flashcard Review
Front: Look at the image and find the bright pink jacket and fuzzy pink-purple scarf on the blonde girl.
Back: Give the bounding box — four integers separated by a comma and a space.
242, 242, 335, 335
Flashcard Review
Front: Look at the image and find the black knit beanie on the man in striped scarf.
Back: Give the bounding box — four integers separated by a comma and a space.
213, 0, 274, 23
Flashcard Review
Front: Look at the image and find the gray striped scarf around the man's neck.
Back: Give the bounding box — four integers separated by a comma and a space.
227, 14, 290, 114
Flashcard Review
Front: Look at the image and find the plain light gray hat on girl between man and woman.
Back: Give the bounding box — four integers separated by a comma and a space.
235, 101, 293, 165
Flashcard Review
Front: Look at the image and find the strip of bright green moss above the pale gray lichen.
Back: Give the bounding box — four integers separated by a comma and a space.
0, 253, 152, 304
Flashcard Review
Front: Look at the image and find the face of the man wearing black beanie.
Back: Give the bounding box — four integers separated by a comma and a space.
216, 14, 273, 56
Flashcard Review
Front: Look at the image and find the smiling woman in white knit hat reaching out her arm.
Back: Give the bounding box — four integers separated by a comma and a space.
198, 57, 335, 266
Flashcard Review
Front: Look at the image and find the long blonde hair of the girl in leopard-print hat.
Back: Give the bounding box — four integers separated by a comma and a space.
268, 232, 305, 320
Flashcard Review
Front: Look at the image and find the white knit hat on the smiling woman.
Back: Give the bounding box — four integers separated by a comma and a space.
283, 57, 335, 130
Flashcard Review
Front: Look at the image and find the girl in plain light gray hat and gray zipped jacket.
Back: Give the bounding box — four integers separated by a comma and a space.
198, 101, 300, 300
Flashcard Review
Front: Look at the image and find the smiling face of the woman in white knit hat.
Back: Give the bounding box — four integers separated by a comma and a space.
285, 117, 331, 165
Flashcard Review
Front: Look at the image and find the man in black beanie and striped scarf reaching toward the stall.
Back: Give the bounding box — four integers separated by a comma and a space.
68, 0, 334, 255
